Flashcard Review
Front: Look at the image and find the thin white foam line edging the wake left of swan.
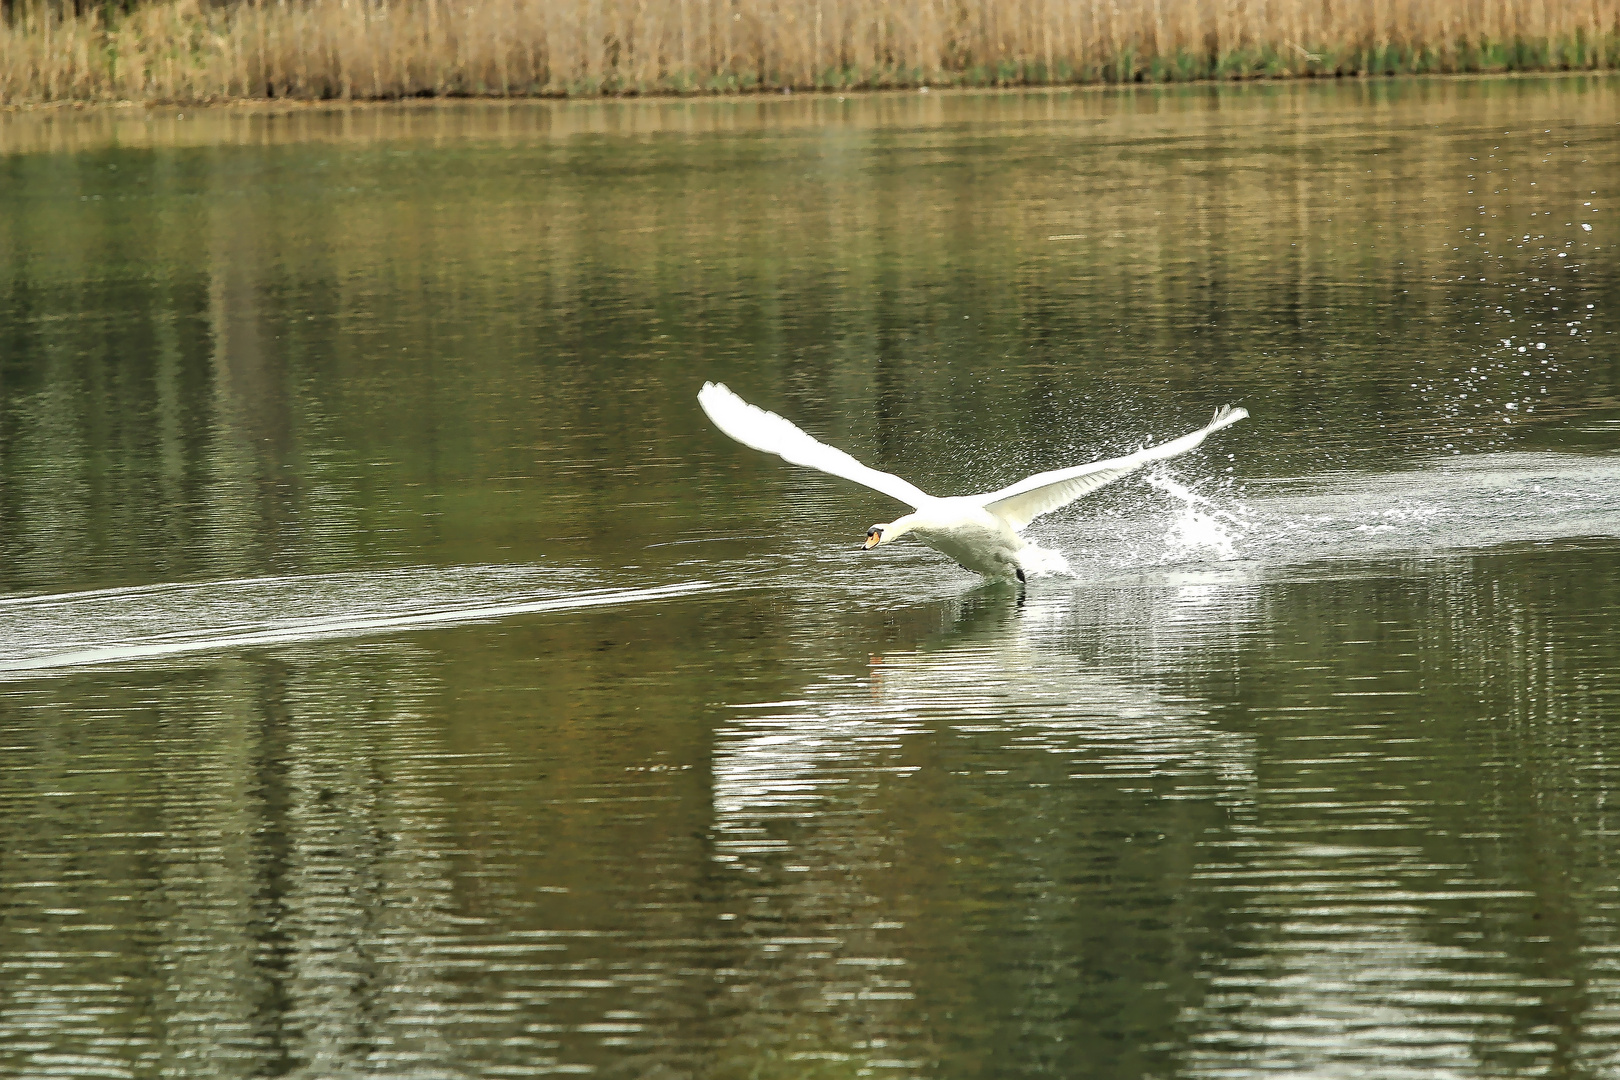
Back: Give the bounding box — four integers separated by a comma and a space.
0, 580, 729, 675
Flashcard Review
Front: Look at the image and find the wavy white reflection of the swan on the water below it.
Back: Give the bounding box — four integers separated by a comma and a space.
713, 589, 1254, 829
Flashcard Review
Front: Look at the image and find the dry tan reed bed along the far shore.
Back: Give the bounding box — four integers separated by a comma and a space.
0, 0, 1620, 104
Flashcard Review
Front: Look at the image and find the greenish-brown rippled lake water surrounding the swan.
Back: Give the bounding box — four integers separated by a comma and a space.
0, 78, 1620, 1080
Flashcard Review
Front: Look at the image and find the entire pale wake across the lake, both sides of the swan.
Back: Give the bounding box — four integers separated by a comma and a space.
0, 453, 1620, 680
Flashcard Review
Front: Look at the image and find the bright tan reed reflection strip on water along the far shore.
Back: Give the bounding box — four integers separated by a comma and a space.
0, 71, 1620, 159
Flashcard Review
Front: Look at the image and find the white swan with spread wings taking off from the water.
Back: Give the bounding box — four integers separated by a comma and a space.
698, 382, 1249, 581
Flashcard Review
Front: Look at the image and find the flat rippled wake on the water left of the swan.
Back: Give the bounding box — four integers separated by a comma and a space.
0, 567, 722, 678
